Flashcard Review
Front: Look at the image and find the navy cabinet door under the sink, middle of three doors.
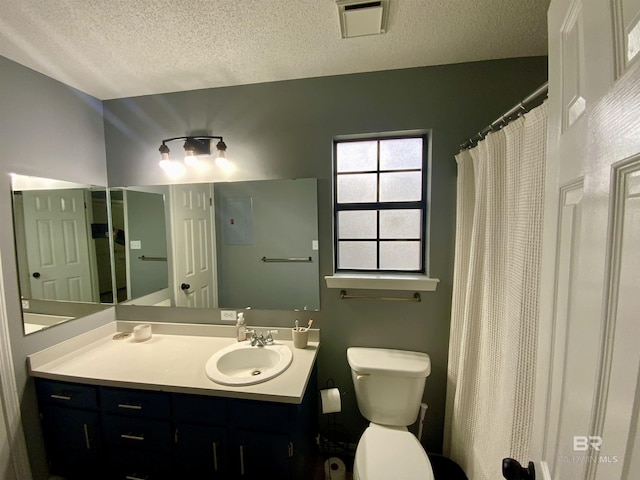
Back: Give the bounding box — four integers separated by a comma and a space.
176, 423, 228, 479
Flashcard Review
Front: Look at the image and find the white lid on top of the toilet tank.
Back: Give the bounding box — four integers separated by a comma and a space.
347, 347, 431, 377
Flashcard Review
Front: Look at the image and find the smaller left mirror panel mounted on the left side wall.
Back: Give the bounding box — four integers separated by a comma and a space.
11, 175, 114, 334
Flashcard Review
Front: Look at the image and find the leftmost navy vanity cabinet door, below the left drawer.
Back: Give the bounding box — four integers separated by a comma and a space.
41, 406, 102, 479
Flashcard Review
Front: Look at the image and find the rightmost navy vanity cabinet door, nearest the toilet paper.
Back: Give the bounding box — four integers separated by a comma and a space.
234, 430, 293, 479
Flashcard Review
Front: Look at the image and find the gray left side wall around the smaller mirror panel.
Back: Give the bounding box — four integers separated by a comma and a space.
0, 57, 114, 480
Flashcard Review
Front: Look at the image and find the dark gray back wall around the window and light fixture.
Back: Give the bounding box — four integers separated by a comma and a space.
104, 57, 547, 452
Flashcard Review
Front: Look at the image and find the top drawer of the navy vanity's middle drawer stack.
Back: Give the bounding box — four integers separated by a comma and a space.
100, 387, 171, 418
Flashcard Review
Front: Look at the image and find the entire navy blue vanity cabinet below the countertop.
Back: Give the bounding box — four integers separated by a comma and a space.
35, 367, 317, 480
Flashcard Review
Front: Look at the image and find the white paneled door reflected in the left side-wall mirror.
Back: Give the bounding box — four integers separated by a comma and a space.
23, 190, 92, 302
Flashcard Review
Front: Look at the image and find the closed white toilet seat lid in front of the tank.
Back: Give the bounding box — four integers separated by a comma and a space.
353, 423, 434, 480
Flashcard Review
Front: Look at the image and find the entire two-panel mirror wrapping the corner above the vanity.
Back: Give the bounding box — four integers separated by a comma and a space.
12, 175, 320, 334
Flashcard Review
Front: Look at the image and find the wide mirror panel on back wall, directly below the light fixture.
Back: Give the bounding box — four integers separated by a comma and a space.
111, 179, 320, 310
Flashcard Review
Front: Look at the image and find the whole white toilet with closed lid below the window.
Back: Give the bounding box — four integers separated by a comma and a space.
347, 347, 434, 480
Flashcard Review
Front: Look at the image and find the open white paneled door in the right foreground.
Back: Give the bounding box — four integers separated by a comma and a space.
536, 0, 640, 480
